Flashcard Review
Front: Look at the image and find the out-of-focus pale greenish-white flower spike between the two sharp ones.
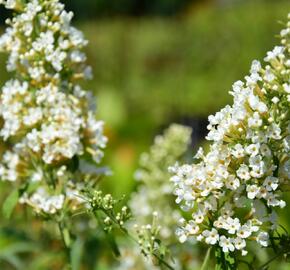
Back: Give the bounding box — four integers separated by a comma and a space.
129, 124, 191, 239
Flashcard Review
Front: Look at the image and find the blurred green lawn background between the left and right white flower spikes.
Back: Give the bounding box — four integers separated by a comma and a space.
0, 0, 290, 195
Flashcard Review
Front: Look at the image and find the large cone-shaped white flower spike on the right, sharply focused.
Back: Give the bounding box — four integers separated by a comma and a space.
170, 14, 290, 255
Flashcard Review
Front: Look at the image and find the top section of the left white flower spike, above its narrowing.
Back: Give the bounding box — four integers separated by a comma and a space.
0, 0, 91, 80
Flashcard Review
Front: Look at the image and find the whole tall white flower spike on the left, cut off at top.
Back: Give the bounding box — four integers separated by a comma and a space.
0, 0, 107, 213
